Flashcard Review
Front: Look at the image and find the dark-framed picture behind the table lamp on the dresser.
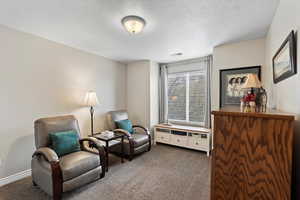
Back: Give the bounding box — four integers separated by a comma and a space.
220, 66, 261, 108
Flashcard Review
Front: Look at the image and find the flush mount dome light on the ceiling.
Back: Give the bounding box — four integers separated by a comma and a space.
122, 15, 146, 34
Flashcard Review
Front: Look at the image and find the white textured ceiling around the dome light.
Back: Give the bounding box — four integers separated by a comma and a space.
0, 0, 279, 62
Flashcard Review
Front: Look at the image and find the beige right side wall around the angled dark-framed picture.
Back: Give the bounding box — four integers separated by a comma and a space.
263, 0, 300, 191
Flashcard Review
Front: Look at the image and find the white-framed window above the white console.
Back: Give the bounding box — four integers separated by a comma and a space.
168, 71, 207, 125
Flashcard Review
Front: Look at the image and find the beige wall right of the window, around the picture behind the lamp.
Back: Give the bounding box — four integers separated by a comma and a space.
211, 39, 265, 110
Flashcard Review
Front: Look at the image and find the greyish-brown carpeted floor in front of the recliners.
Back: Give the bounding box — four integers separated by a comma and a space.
0, 145, 210, 200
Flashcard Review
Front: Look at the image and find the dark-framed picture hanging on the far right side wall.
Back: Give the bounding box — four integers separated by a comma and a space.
272, 31, 297, 84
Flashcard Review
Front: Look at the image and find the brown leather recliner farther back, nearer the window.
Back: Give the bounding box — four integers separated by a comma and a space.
108, 110, 151, 160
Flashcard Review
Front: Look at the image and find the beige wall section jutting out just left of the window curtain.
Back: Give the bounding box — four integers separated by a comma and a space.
127, 60, 159, 128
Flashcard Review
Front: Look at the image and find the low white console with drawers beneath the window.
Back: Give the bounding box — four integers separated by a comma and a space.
154, 124, 211, 156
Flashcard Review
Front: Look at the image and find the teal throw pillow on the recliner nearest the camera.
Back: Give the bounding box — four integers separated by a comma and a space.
49, 131, 80, 157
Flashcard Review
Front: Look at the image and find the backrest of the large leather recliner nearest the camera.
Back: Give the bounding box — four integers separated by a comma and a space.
34, 115, 80, 148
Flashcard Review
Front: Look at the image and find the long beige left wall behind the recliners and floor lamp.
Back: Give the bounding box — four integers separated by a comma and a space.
0, 26, 126, 178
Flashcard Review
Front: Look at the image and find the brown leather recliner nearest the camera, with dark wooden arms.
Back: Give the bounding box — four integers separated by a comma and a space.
31, 116, 105, 200
